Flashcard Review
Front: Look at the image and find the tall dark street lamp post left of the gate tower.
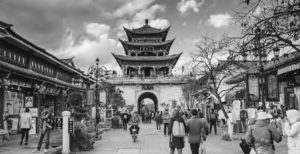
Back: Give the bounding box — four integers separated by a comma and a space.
89, 57, 106, 138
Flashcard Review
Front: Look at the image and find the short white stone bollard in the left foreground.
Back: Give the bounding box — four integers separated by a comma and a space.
62, 111, 71, 154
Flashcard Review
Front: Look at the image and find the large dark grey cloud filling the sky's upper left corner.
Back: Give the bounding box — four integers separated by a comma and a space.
0, 0, 102, 49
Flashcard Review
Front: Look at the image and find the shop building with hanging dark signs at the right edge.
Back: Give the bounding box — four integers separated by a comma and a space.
264, 52, 300, 110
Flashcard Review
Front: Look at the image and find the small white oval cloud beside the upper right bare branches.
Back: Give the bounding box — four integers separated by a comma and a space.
208, 13, 232, 28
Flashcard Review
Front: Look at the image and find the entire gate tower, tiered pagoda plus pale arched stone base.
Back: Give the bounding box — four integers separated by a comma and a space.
106, 19, 187, 111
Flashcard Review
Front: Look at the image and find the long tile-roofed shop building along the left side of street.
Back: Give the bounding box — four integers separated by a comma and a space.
0, 21, 95, 134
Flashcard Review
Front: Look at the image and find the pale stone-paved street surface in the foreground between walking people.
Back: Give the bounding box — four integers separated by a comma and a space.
82, 123, 286, 154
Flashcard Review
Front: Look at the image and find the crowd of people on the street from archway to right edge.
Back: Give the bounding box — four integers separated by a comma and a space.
121, 105, 300, 154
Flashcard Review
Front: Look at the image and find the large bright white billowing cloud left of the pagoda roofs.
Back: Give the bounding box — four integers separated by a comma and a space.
55, 23, 122, 71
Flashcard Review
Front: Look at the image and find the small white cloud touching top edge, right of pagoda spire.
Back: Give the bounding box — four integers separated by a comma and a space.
177, 0, 205, 15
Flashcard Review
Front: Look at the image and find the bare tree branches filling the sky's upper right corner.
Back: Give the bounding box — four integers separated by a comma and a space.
235, 0, 300, 56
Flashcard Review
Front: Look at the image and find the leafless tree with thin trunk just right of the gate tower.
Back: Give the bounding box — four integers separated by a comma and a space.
192, 36, 244, 117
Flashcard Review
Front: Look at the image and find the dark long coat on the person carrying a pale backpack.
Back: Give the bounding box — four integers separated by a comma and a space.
169, 116, 187, 149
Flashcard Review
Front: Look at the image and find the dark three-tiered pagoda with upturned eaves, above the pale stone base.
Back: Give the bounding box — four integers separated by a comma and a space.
113, 19, 181, 78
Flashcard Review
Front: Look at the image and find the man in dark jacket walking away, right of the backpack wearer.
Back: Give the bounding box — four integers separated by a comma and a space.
186, 109, 208, 154
